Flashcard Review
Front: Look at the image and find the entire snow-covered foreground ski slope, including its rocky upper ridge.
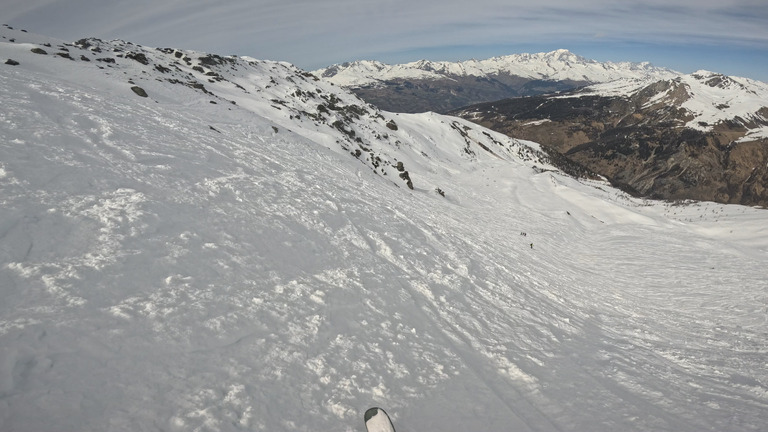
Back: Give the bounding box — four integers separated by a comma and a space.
0, 28, 768, 432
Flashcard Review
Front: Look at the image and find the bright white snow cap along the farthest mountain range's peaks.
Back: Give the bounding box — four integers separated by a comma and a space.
314, 49, 677, 87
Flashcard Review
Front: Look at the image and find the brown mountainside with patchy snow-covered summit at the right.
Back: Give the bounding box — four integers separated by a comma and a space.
456, 71, 768, 206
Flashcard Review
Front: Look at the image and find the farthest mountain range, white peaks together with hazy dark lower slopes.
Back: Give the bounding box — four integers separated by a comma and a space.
313, 49, 678, 112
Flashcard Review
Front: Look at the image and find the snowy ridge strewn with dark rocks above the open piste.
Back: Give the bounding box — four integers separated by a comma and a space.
0, 25, 553, 197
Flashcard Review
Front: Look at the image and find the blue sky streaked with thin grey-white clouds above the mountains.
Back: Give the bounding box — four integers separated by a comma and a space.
2, 0, 768, 82
